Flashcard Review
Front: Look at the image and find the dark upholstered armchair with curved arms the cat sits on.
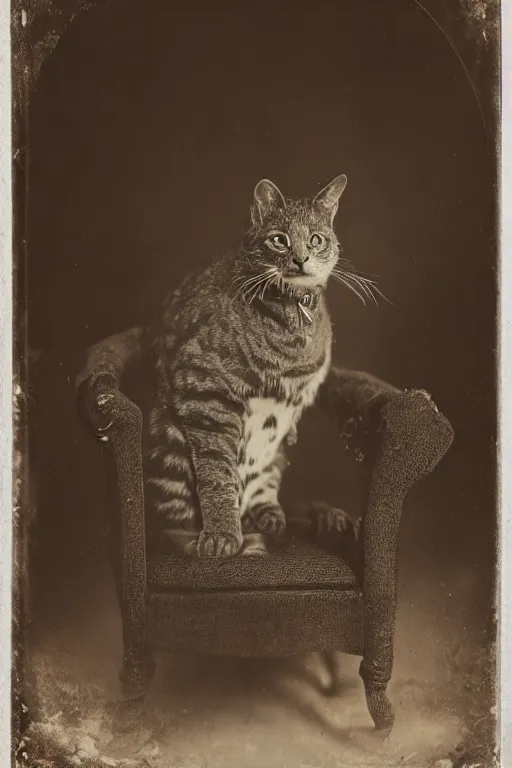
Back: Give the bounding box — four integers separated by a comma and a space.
78, 329, 453, 733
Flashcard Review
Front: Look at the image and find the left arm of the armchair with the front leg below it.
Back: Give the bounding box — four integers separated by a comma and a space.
77, 328, 147, 697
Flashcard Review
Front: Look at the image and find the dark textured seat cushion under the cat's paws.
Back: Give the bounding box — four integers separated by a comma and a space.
147, 535, 358, 592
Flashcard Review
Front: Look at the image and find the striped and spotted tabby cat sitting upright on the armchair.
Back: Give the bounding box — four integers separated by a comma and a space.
147, 176, 347, 557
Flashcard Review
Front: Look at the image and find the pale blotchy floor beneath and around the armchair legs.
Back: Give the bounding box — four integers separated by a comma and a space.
24, 552, 482, 768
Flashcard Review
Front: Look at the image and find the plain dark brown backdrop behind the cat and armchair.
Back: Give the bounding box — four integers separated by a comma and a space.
23, 0, 497, 766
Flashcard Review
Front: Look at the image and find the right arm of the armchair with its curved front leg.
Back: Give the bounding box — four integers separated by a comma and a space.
322, 369, 453, 729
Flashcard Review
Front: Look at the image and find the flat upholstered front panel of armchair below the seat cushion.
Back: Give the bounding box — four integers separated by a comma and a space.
147, 588, 363, 657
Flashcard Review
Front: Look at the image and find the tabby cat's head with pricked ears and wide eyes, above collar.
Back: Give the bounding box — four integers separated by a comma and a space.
243, 175, 347, 288
